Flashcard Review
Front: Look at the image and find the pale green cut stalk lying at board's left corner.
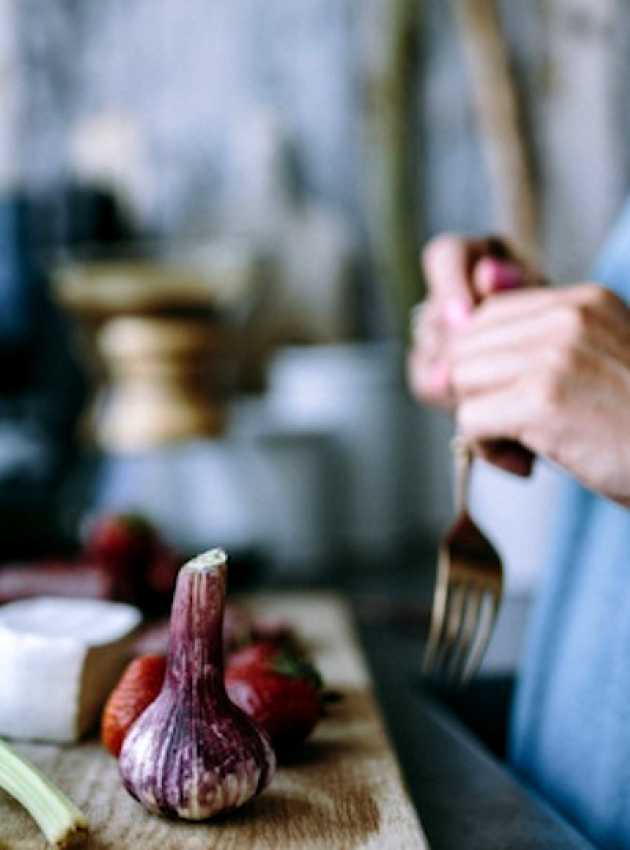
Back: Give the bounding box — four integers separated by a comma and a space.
0, 740, 88, 850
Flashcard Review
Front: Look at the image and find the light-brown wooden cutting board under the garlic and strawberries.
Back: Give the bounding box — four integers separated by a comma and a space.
0, 594, 428, 850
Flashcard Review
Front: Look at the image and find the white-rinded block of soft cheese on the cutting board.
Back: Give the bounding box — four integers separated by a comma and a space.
0, 596, 141, 742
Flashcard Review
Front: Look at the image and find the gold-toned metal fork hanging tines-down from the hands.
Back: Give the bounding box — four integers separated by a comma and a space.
422, 437, 503, 685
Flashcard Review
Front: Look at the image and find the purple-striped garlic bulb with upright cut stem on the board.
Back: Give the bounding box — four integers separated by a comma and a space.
119, 549, 275, 820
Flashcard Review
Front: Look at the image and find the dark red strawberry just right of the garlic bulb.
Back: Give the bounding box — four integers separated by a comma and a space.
225, 643, 322, 756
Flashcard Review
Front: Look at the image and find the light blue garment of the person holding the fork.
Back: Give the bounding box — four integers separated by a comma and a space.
510, 203, 630, 850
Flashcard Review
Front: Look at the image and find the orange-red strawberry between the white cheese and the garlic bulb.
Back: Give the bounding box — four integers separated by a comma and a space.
101, 655, 166, 758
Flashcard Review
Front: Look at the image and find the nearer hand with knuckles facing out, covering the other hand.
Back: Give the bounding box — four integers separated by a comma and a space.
451, 283, 630, 505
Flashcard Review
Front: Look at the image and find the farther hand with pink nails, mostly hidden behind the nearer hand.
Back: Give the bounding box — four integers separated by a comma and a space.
407, 234, 544, 474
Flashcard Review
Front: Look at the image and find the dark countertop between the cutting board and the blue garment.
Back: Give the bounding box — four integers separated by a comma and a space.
350, 592, 593, 850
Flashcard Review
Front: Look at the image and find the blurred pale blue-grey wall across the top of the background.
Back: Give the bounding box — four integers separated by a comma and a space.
8, 0, 630, 278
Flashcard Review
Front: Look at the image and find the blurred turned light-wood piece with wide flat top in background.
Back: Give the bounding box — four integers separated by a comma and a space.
56, 261, 252, 453
